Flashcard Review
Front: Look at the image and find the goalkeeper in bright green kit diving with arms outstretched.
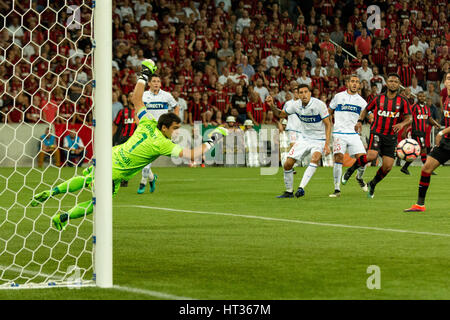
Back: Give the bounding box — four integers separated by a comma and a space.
31, 59, 227, 230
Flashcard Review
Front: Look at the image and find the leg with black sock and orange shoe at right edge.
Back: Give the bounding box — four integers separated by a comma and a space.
404, 147, 450, 212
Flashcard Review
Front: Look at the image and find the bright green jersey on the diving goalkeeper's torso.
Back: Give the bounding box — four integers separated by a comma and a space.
112, 109, 182, 180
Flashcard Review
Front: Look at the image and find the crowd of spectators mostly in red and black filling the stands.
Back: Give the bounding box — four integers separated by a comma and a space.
0, 0, 450, 165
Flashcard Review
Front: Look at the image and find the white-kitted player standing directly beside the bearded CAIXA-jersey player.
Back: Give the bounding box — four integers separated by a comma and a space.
329, 75, 367, 198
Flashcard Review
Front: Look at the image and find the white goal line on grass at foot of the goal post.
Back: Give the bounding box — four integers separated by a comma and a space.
0, 265, 194, 300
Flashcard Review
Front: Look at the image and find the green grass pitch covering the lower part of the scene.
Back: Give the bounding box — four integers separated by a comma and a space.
0, 167, 450, 300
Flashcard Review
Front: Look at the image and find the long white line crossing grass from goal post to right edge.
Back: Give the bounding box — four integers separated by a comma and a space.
125, 205, 450, 237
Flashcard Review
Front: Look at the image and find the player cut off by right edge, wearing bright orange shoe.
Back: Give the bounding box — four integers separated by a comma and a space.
404, 72, 450, 212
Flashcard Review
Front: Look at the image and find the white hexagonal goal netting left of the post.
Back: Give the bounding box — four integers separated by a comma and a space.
0, 0, 94, 287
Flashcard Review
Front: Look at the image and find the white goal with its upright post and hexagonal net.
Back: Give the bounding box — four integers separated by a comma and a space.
0, 0, 113, 289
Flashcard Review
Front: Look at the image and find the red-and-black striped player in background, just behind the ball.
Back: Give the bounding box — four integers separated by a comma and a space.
400, 91, 440, 175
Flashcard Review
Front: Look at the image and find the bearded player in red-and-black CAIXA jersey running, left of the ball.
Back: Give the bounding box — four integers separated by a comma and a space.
342, 73, 411, 198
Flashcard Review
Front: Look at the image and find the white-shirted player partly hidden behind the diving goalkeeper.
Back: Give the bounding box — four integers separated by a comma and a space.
137, 75, 179, 194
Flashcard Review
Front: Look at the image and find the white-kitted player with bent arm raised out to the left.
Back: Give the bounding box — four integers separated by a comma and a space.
266, 84, 331, 198
